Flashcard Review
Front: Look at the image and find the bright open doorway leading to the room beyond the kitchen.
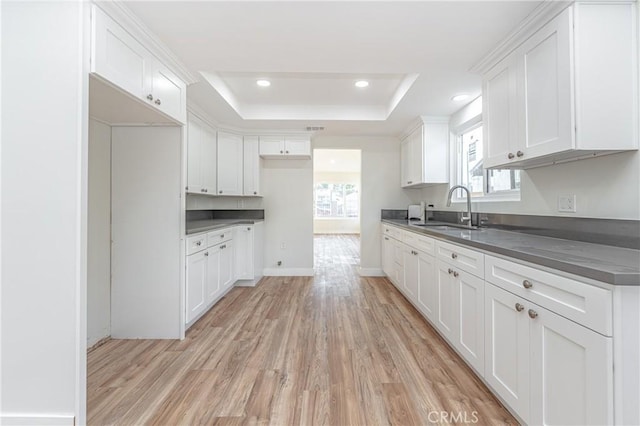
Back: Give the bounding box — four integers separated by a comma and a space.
313, 149, 361, 268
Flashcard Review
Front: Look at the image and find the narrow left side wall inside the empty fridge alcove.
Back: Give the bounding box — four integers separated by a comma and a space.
87, 120, 111, 347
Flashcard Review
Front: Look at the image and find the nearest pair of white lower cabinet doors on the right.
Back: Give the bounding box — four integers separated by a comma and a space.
484, 283, 613, 425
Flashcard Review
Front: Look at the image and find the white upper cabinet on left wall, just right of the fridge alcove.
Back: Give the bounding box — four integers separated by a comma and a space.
186, 114, 217, 195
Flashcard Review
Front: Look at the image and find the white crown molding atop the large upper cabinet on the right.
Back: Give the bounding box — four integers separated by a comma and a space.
469, 0, 573, 74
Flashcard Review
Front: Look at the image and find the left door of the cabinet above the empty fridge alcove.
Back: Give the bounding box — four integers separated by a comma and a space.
91, 6, 152, 99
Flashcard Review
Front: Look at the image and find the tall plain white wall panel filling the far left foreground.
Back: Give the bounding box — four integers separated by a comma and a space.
0, 1, 88, 425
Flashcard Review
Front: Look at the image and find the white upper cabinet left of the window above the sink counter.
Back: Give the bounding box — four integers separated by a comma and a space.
400, 117, 449, 188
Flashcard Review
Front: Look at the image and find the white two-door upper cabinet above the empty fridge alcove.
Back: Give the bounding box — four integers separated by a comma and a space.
91, 6, 187, 123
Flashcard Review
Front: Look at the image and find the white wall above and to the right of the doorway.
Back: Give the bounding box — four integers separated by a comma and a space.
313, 136, 411, 275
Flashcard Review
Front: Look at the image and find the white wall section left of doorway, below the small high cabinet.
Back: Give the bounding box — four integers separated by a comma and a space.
261, 160, 313, 275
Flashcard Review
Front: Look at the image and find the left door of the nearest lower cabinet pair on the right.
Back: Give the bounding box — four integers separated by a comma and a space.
484, 283, 535, 423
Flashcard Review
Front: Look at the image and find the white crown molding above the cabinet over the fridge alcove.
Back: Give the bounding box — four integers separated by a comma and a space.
94, 0, 199, 85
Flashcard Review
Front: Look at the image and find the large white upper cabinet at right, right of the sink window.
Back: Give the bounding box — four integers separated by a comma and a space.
482, 2, 638, 169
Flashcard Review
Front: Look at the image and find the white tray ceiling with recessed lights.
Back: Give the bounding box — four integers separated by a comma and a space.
124, 1, 541, 135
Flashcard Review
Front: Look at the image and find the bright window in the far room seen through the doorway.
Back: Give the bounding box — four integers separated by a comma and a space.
313, 183, 360, 218
